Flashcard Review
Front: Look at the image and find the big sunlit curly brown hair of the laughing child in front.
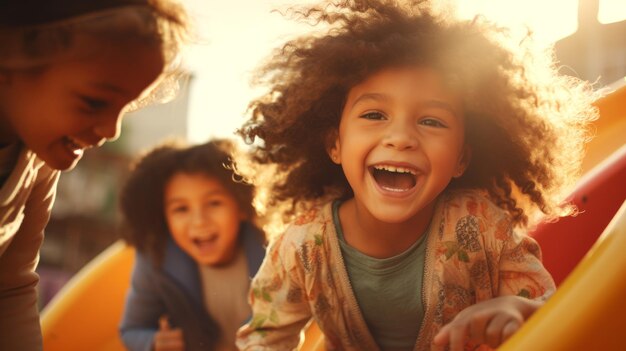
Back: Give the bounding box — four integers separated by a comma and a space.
238, 0, 597, 231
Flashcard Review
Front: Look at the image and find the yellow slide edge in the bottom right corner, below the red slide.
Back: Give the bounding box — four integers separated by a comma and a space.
499, 201, 626, 351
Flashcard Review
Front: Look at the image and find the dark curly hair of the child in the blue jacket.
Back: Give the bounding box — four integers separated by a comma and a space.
120, 139, 260, 264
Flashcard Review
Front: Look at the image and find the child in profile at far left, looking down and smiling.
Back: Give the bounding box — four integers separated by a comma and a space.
0, 0, 187, 350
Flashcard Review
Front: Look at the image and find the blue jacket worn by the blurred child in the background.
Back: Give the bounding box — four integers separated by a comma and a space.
120, 222, 265, 351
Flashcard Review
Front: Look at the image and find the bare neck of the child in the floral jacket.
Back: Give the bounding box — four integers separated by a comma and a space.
339, 198, 435, 258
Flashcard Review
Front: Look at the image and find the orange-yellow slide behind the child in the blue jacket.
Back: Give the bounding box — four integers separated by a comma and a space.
41, 241, 323, 351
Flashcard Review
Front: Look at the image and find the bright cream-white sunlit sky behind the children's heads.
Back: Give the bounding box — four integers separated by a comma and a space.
184, 0, 608, 141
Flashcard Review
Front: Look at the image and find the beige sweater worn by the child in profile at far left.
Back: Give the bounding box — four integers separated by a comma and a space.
0, 149, 59, 351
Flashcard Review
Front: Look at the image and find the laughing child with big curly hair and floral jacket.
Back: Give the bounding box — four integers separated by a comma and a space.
237, 0, 595, 350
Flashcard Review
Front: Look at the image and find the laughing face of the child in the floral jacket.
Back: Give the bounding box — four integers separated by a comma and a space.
329, 67, 467, 224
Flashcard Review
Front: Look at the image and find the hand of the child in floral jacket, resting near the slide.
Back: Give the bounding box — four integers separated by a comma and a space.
433, 296, 542, 351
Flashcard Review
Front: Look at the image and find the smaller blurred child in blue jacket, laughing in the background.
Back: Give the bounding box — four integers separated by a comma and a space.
121, 140, 265, 350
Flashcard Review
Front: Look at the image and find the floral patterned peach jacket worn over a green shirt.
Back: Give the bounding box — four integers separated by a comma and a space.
237, 191, 555, 351
